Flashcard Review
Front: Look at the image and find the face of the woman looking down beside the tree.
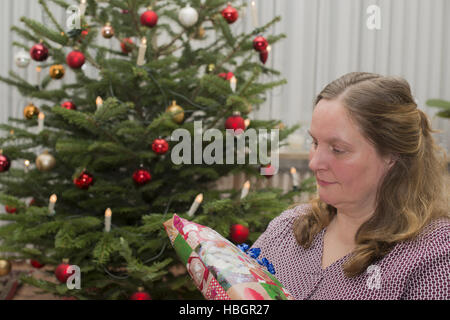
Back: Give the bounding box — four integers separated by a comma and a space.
309, 99, 392, 212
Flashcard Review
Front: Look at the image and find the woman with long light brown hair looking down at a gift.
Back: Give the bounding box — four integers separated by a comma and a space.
253, 72, 450, 299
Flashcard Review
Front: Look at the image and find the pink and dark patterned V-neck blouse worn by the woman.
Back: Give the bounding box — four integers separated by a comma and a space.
252, 204, 450, 300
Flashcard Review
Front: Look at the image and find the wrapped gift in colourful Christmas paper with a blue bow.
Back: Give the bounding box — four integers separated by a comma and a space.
164, 214, 293, 300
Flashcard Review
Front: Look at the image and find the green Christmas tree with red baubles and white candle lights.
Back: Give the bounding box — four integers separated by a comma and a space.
0, 0, 314, 299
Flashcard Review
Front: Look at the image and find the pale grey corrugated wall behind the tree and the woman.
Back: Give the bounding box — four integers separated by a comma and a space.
0, 0, 450, 151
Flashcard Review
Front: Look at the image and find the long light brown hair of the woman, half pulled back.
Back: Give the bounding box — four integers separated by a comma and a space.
294, 72, 449, 277
